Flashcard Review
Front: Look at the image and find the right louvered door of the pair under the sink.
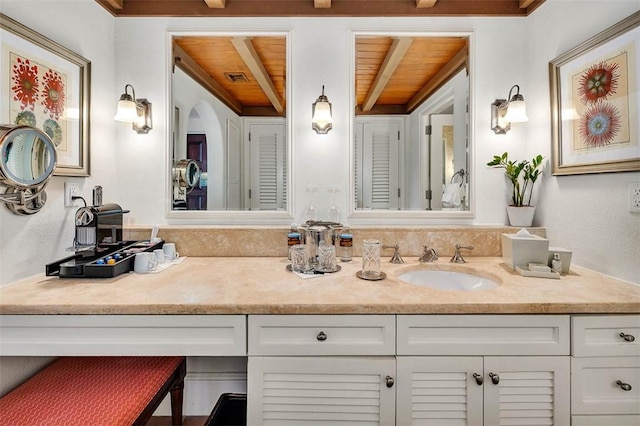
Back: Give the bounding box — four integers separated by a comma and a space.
484, 356, 570, 426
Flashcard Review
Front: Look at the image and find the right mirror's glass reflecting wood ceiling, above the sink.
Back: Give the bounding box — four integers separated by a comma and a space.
352, 33, 470, 212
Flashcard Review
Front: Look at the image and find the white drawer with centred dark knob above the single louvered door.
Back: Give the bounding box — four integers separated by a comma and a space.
248, 315, 395, 355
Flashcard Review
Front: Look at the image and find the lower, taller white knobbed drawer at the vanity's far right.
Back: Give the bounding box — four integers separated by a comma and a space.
571, 357, 640, 414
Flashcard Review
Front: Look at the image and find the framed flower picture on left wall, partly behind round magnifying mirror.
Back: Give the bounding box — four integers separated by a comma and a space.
0, 14, 91, 176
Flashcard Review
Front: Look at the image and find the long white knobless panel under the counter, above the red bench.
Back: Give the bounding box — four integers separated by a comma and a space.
0, 315, 247, 356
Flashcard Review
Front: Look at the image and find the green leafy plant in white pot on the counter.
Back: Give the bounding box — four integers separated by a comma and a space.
487, 152, 543, 226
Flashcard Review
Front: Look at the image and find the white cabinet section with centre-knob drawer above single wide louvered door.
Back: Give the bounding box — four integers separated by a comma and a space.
247, 315, 396, 426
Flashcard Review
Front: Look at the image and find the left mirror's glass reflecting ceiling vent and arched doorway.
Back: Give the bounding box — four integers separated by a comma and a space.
169, 32, 288, 211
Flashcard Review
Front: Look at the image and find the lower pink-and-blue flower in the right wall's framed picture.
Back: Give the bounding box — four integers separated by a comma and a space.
578, 102, 621, 148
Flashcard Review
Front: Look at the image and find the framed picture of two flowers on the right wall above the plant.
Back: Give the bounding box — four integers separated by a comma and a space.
549, 12, 640, 175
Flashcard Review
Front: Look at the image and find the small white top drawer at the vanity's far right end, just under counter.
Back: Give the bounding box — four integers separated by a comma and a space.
572, 315, 640, 356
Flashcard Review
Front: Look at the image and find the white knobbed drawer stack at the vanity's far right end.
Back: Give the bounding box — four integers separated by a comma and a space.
571, 315, 640, 426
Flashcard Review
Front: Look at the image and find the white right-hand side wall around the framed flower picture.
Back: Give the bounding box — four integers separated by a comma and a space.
523, 0, 640, 283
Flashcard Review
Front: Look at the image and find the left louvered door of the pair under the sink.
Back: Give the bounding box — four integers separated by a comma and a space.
396, 356, 483, 426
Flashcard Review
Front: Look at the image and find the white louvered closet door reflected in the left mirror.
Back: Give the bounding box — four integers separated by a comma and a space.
249, 124, 286, 210
